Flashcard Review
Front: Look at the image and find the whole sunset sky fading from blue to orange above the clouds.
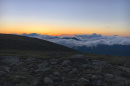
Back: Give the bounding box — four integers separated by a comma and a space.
0, 0, 130, 36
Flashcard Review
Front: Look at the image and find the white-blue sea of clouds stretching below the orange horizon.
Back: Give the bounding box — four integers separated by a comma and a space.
22, 33, 130, 48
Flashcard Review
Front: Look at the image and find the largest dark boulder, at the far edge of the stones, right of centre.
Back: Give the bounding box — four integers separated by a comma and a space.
70, 54, 90, 65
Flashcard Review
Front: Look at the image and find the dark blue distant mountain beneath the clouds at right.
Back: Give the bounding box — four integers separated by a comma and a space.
73, 44, 130, 57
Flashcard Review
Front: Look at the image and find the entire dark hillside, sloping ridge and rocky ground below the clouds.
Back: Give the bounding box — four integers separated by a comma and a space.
0, 34, 130, 86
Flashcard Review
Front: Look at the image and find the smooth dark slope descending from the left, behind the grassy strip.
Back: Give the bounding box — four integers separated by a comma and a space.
0, 34, 75, 52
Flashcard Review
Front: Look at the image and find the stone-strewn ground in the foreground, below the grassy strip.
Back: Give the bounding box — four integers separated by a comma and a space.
0, 54, 130, 86
